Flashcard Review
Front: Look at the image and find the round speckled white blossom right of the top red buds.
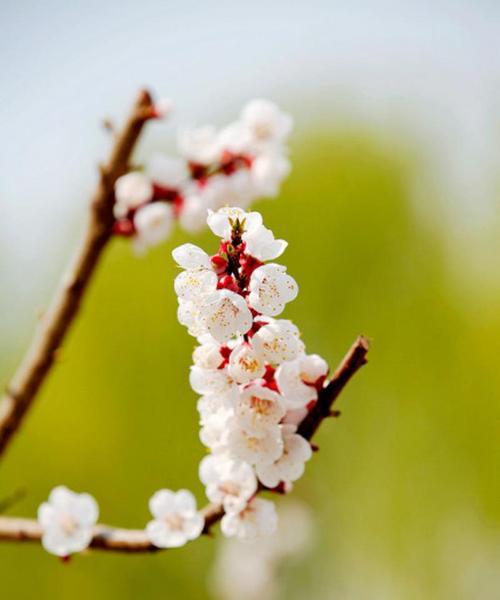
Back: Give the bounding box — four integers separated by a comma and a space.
248, 263, 298, 317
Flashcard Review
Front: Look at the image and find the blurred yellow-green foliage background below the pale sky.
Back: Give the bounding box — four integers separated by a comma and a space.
0, 127, 500, 600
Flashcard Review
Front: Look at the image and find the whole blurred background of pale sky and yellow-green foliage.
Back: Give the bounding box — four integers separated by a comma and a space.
0, 0, 500, 600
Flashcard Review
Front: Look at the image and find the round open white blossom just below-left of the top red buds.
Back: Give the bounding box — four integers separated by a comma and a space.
201, 290, 253, 343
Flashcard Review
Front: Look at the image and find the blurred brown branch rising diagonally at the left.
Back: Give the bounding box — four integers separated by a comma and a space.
0, 91, 153, 457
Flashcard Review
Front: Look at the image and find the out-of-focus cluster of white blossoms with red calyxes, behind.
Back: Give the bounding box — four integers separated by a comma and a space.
114, 100, 292, 252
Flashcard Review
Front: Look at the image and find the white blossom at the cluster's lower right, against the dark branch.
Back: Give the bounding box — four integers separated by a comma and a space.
257, 425, 312, 488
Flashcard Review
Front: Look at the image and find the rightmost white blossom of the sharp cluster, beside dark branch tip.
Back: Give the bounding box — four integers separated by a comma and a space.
275, 354, 328, 409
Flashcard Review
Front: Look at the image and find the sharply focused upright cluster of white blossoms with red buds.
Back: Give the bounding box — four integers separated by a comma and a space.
173, 207, 328, 539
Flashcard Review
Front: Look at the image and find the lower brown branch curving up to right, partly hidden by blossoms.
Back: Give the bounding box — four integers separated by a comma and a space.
0, 337, 368, 552
